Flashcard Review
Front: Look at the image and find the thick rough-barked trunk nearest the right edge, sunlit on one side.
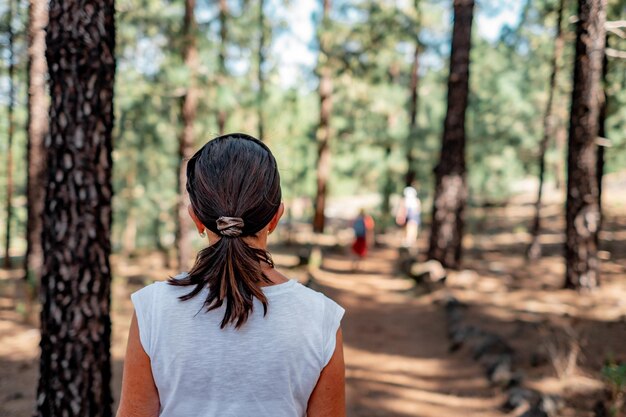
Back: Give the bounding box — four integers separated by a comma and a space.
565, 0, 606, 289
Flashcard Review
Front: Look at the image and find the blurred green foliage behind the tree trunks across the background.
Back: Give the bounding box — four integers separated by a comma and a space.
0, 0, 626, 249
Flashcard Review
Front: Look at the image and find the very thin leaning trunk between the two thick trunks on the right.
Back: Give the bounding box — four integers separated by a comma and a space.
526, 0, 565, 259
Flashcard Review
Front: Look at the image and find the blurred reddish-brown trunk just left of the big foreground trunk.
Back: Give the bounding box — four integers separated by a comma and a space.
24, 0, 49, 284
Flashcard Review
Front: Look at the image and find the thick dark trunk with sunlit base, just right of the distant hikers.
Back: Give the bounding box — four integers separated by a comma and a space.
428, 0, 474, 268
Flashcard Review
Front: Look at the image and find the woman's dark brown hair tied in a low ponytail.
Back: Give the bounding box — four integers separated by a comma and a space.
168, 133, 281, 328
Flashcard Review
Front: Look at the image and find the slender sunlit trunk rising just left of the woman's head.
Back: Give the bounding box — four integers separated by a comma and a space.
176, 0, 198, 271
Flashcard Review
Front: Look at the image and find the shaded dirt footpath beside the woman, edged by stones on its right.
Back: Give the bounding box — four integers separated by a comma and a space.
315, 249, 505, 417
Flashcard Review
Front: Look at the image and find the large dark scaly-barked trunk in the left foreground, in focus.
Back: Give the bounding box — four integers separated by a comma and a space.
36, 0, 115, 417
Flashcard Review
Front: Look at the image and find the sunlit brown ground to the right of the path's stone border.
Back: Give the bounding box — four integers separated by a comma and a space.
446, 196, 626, 416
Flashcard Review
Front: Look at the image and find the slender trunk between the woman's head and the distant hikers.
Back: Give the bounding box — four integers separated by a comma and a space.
313, 0, 333, 233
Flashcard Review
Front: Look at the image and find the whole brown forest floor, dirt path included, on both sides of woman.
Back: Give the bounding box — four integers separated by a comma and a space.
0, 182, 626, 417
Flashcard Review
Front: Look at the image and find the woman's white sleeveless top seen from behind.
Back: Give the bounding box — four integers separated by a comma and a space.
131, 273, 344, 417
